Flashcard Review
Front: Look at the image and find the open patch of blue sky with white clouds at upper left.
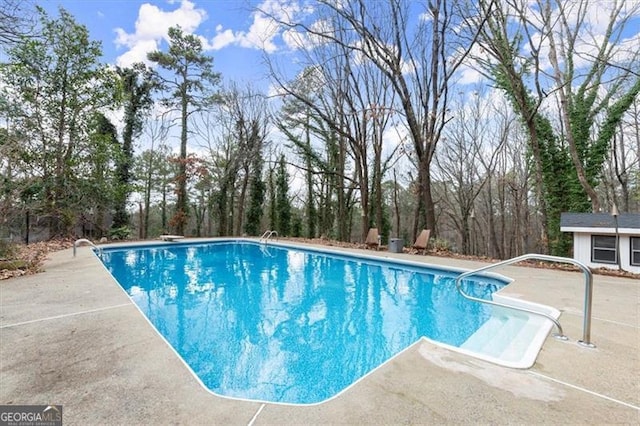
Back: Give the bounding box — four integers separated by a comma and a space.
38, 0, 297, 87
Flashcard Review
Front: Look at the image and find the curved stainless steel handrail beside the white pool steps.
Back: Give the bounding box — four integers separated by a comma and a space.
456, 253, 596, 348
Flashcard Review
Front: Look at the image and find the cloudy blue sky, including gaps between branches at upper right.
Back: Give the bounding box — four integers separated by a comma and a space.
33, 0, 640, 166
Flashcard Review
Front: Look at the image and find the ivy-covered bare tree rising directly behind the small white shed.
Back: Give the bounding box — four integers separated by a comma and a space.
544, 0, 640, 212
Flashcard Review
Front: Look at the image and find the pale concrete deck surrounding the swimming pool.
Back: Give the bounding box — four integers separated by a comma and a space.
0, 241, 640, 425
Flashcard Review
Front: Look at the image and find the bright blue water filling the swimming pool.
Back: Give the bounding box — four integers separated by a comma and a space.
101, 242, 505, 404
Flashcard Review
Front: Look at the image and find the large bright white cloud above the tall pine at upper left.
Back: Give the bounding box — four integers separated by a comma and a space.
115, 0, 207, 66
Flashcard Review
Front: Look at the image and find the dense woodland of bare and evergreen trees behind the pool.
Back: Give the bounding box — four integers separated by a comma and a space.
0, 0, 640, 258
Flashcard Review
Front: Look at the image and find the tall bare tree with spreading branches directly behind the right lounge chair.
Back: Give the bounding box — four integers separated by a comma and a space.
262, 0, 490, 240
